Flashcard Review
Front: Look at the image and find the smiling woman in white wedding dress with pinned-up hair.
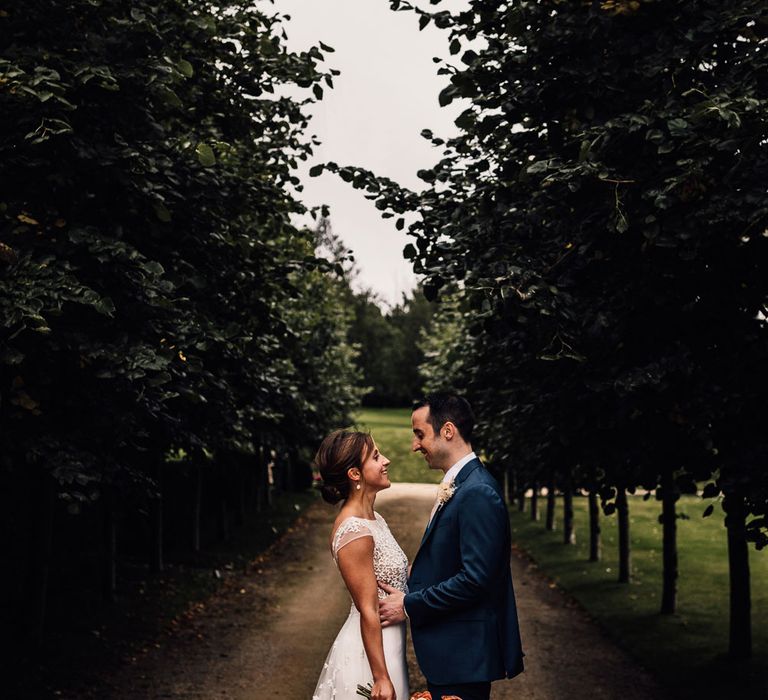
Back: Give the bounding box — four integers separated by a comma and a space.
312, 430, 409, 700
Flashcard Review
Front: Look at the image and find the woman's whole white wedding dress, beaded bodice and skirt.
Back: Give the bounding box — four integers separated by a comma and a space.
312, 513, 410, 700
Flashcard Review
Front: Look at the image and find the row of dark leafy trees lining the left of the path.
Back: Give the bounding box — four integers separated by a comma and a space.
0, 0, 357, 656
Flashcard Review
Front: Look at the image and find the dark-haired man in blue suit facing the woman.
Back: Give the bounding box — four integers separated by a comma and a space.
379, 394, 523, 700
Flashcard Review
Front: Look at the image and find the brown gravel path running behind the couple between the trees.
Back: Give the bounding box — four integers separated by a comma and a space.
91, 484, 662, 700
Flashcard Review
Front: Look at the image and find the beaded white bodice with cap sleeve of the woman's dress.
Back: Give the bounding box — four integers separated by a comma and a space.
331, 513, 408, 598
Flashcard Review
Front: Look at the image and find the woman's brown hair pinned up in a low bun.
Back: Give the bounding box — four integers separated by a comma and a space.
315, 430, 373, 503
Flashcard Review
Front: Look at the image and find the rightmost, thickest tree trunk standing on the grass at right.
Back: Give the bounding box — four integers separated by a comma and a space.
723, 493, 752, 659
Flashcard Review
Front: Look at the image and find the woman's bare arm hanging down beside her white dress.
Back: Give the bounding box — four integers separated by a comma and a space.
337, 537, 396, 700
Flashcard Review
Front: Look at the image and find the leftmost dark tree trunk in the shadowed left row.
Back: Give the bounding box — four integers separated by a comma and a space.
27, 474, 56, 649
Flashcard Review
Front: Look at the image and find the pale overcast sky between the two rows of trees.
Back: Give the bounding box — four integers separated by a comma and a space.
275, 0, 465, 304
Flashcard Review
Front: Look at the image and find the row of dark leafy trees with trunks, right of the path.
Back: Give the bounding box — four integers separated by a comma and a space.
324, 0, 768, 657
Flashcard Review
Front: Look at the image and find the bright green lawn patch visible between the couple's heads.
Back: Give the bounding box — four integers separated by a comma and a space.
356, 408, 443, 484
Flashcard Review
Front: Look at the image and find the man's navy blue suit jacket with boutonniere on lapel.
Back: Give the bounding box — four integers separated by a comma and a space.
405, 459, 523, 685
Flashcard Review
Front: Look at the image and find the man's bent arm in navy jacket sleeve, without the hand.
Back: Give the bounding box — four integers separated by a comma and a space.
404, 484, 508, 626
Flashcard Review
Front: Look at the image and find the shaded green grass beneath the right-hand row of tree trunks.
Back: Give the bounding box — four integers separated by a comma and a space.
510, 496, 768, 700
